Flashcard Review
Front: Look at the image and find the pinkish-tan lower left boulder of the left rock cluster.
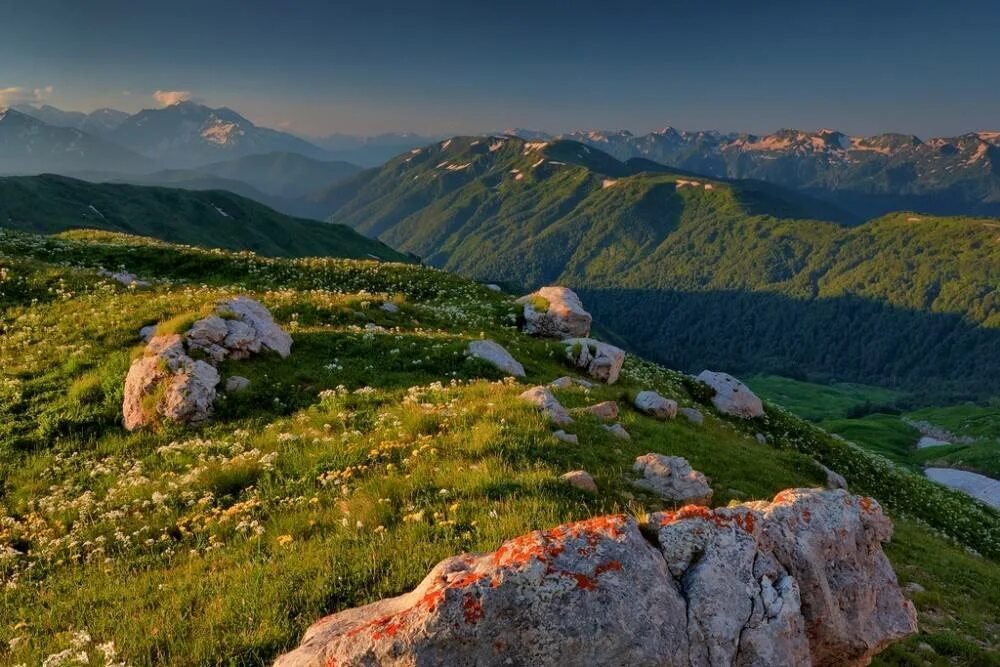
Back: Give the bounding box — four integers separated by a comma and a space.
122, 334, 219, 431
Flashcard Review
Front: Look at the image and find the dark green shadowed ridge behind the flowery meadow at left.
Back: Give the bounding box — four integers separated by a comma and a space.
0, 175, 405, 261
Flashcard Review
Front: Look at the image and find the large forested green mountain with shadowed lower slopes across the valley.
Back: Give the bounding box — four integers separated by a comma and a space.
323, 137, 1000, 395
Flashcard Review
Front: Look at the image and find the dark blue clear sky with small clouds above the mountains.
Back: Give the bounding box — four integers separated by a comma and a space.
0, 0, 1000, 137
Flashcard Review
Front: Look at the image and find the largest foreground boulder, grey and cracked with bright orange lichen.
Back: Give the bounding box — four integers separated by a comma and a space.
276, 489, 916, 667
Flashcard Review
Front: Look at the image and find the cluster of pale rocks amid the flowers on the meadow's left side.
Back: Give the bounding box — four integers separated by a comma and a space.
122, 297, 292, 431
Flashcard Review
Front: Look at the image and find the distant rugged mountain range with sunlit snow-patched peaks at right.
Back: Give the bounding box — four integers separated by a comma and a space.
510, 127, 1000, 219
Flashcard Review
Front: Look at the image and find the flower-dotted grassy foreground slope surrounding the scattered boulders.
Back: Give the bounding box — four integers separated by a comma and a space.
0, 230, 1000, 665
